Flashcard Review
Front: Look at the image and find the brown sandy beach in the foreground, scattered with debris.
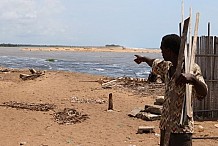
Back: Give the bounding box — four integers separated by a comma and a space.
0, 69, 218, 146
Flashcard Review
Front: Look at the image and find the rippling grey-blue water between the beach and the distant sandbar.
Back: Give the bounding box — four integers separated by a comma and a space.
0, 47, 162, 78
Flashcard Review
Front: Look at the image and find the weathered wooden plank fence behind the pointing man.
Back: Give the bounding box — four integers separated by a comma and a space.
197, 36, 218, 118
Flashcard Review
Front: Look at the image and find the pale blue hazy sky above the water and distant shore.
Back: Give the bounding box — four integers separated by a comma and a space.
0, 0, 218, 48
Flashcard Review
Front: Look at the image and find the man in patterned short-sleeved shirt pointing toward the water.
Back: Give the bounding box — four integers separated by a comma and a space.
134, 34, 208, 146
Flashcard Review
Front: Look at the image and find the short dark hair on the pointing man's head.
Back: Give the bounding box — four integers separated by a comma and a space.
161, 34, 181, 55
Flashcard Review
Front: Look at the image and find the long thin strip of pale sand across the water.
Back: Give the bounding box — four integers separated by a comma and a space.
21, 47, 161, 53
